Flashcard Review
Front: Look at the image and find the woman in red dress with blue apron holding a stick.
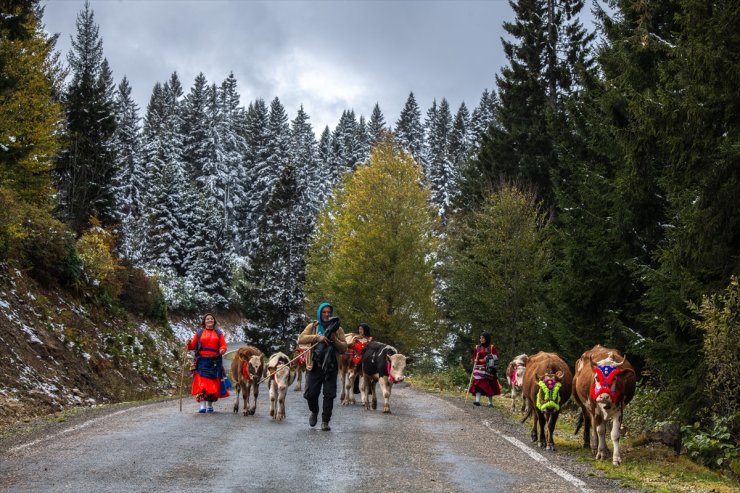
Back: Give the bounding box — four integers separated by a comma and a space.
187, 313, 229, 413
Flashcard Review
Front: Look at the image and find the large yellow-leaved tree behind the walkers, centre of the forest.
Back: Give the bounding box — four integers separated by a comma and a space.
306, 135, 438, 352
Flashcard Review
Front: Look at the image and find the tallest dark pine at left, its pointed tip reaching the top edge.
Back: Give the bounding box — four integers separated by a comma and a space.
57, 2, 117, 232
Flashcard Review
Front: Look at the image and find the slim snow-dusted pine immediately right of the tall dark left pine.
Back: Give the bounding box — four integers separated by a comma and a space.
111, 77, 145, 263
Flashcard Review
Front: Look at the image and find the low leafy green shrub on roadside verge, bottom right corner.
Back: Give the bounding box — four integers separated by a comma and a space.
681, 415, 740, 469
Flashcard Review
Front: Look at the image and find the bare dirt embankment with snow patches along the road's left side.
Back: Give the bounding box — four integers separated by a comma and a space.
0, 264, 247, 426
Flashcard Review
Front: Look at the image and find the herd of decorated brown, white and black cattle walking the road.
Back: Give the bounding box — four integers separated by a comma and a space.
231, 333, 636, 465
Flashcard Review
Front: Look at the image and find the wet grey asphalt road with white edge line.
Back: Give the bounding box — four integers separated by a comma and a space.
0, 378, 627, 493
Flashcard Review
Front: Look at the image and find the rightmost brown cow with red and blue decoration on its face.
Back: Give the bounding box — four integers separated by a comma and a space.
573, 344, 637, 466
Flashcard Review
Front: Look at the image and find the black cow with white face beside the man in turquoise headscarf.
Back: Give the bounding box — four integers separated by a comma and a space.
360, 341, 413, 413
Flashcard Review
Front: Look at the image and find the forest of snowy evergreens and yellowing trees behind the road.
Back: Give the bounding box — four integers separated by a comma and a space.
0, 0, 740, 465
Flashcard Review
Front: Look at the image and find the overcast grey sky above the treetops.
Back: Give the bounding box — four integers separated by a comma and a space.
44, 0, 572, 134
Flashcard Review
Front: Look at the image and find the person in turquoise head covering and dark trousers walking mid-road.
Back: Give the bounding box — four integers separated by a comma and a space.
298, 303, 347, 431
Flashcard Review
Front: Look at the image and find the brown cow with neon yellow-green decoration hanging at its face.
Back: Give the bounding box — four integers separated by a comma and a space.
522, 351, 573, 450
